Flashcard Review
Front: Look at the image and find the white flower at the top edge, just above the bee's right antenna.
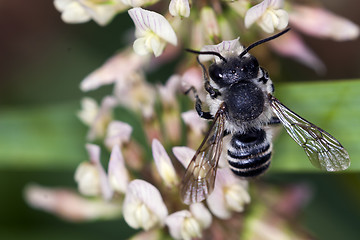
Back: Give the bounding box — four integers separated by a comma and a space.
245, 0, 289, 33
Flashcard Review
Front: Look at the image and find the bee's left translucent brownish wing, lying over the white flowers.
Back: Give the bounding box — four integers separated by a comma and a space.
180, 105, 225, 204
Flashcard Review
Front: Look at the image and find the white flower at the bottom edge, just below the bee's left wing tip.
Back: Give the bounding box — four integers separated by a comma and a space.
165, 203, 212, 240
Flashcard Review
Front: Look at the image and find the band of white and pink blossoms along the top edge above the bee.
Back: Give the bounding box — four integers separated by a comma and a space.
54, 0, 359, 72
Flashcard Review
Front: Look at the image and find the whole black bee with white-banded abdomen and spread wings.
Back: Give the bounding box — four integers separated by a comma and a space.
180, 29, 350, 204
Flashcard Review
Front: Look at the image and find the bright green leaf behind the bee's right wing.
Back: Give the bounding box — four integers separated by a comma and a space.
271, 80, 360, 171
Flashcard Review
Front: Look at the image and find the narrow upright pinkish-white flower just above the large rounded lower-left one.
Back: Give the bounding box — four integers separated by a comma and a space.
108, 145, 130, 193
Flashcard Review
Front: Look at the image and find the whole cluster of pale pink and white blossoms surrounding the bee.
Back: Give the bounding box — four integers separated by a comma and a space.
26, 0, 359, 239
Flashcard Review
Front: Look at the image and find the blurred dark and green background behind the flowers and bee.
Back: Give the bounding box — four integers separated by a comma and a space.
0, 0, 360, 239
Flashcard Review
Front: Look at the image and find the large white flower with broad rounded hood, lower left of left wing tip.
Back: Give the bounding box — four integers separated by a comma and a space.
123, 179, 168, 230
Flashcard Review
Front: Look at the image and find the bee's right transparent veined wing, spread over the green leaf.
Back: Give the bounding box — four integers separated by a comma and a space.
270, 96, 350, 171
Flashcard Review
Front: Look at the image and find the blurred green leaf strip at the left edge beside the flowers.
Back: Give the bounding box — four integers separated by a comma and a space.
0, 103, 87, 170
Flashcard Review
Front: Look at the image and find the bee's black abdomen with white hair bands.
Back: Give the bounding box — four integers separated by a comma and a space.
227, 129, 272, 177
